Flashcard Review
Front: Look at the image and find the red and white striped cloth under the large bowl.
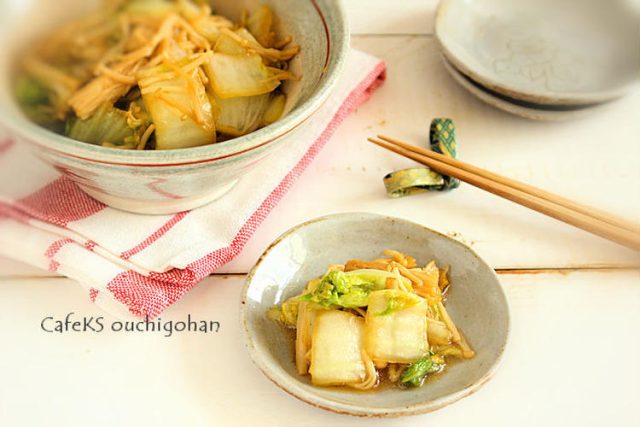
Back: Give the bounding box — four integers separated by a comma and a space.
0, 50, 385, 318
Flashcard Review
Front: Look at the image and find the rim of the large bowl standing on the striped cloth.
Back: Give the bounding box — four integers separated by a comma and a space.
0, 0, 350, 167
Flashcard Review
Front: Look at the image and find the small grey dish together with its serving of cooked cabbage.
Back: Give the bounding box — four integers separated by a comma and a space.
241, 213, 509, 417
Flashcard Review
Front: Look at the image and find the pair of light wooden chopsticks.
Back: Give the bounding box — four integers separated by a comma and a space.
368, 135, 640, 251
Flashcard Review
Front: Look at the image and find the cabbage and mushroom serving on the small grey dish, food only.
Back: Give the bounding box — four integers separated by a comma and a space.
268, 251, 475, 390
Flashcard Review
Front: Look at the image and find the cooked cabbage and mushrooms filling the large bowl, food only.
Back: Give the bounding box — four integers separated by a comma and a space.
15, 0, 300, 150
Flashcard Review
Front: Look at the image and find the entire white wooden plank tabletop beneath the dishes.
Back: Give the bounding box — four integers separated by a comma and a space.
0, 0, 640, 426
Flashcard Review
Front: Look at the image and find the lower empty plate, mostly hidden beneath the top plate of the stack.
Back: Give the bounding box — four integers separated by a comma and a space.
442, 57, 601, 121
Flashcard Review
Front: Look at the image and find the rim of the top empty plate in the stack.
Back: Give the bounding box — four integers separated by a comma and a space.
434, 0, 635, 105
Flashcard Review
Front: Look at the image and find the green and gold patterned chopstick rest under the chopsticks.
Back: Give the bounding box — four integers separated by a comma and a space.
383, 118, 460, 198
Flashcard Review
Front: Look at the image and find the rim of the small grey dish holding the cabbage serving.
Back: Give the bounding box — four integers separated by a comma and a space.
240, 212, 511, 418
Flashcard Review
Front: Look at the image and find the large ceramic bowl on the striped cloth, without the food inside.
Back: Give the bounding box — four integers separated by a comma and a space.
0, 0, 349, 214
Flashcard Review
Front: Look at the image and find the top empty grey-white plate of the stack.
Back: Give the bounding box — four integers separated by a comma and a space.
436, 0, 640, 105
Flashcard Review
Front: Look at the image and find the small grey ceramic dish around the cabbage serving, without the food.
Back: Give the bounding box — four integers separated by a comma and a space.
241, 213, 509, 417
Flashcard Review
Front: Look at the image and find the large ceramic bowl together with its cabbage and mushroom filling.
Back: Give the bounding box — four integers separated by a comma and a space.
0, 0, 349, 214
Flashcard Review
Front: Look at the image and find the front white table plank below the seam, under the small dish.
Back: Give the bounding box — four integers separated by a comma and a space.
0, 272, 640, 427
